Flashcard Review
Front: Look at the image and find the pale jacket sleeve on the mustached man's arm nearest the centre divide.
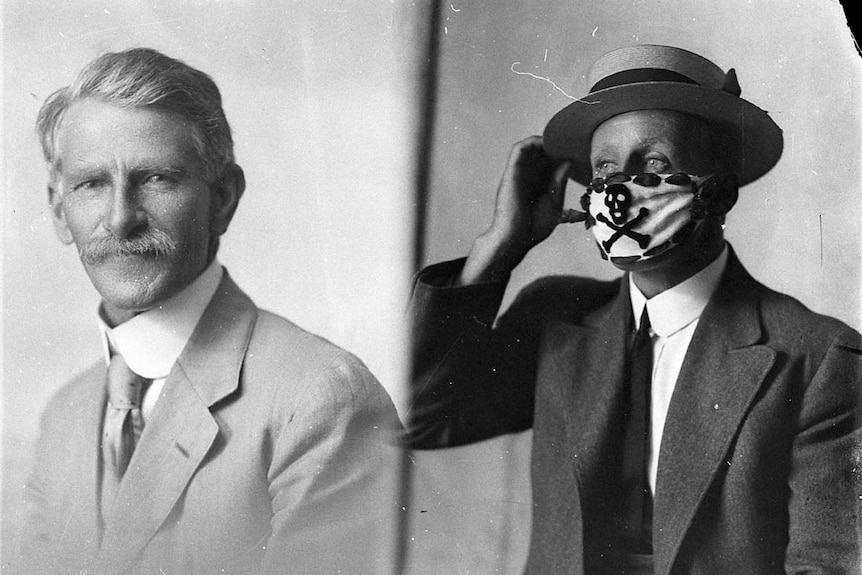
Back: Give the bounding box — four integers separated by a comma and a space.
262, 352, 401, 574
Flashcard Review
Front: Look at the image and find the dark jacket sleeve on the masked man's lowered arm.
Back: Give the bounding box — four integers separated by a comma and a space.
785, 329, 862, 574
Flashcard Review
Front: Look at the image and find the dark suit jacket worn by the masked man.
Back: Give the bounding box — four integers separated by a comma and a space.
408, 253, 862, 575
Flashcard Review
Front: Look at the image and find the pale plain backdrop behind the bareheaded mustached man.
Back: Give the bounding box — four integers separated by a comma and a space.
0, 0, 416, 568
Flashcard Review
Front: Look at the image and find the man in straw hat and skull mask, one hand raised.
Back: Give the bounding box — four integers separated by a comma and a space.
408, 45, 862, 575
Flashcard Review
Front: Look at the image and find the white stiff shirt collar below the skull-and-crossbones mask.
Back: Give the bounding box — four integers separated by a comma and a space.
629, 244, 728, 337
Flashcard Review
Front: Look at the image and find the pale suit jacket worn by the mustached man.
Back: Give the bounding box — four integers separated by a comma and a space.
24, 274, 398, 575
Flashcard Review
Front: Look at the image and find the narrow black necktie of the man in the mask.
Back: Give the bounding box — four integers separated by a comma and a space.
622, 306, 653, 553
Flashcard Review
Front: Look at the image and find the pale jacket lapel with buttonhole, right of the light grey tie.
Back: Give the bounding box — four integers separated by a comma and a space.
101, 272, 257, 571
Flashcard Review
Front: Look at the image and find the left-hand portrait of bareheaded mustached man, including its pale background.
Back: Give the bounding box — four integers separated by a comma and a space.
2, 1, 415, 575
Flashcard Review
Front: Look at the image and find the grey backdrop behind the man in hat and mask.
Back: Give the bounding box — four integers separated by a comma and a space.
413, 0, 862, 574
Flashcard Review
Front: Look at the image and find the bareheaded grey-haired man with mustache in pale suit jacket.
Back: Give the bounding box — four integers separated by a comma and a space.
24, 48, 397, 574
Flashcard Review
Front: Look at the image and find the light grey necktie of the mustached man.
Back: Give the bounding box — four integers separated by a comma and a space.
101, 353, 149, 518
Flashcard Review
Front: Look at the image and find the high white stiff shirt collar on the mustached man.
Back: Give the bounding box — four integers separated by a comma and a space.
99, 259, 224, 379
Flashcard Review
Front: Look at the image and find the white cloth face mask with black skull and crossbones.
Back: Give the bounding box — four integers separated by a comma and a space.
581, 173, 737, 264
